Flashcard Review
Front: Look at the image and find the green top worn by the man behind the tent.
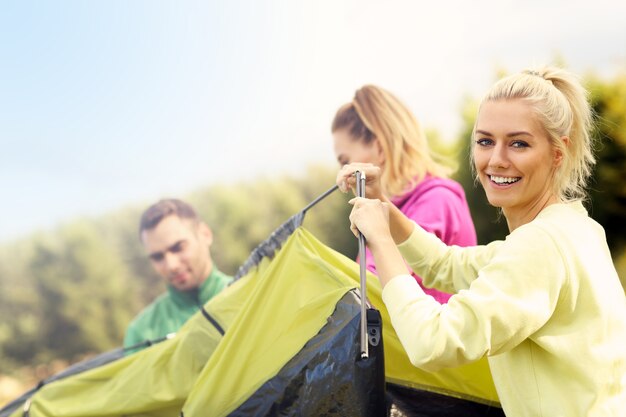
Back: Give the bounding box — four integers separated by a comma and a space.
124, 267, 233, 347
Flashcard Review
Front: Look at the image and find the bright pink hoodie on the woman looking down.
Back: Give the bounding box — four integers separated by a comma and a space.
365, 176, 476, 304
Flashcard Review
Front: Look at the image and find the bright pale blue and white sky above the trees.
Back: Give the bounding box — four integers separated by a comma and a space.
0, 0, 626, 242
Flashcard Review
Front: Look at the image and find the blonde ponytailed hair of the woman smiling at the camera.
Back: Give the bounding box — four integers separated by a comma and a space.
474, 67, 596, 202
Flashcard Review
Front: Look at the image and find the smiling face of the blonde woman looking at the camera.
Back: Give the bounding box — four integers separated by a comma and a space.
473, 100, 561, 223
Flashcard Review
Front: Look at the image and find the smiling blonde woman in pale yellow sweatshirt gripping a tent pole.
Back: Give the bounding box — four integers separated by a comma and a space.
337, 67, 626, 417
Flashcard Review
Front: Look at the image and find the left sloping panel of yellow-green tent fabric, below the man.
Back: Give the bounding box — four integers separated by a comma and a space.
4, 272, 257, 417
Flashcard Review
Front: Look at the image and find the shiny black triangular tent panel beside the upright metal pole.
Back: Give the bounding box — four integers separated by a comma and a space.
219, 291, 387, 417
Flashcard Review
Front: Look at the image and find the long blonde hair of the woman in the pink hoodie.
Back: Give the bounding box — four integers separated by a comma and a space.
331, 85, 452, 196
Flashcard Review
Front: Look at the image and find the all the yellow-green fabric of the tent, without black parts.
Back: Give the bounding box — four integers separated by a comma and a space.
4, 227, 498, 417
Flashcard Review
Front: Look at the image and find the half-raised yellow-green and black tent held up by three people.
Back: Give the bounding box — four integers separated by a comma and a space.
0, 189, 503, 417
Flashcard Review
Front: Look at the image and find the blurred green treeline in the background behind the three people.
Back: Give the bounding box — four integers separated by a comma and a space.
0, 69, 626, 374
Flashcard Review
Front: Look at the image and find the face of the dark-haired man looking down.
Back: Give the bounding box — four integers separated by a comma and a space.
141, 215, 213, 291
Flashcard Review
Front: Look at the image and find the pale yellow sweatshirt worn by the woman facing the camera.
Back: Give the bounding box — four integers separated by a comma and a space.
383, 203, 626, 417
